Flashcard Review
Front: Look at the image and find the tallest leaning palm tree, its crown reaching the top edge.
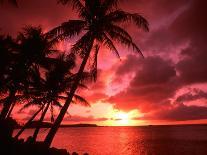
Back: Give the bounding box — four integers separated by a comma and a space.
44, 0, 148, 147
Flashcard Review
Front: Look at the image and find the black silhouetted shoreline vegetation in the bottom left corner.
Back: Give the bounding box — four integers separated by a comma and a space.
0, 118, 87, 155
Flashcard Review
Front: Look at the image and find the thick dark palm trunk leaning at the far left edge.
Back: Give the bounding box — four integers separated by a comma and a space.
0, 91, 16, 120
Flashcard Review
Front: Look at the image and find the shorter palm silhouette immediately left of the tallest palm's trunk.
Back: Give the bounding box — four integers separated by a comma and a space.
29, 55, 89, 141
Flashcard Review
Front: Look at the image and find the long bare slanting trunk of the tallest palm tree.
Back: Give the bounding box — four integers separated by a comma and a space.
44, 39, 94, 147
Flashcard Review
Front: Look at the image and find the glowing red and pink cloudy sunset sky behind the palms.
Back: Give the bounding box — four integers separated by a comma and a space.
0, 0, 207, 126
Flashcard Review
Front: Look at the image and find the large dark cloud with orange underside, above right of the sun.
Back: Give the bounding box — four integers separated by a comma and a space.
108, 57, 178, 112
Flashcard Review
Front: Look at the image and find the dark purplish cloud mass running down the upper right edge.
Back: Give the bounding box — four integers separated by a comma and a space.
171, 0, 207, 84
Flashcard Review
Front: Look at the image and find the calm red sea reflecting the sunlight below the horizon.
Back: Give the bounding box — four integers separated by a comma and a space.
13, 126, 207, 155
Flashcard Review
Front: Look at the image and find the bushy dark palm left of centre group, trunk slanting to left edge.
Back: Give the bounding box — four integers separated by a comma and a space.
1, 26, 57, 119
